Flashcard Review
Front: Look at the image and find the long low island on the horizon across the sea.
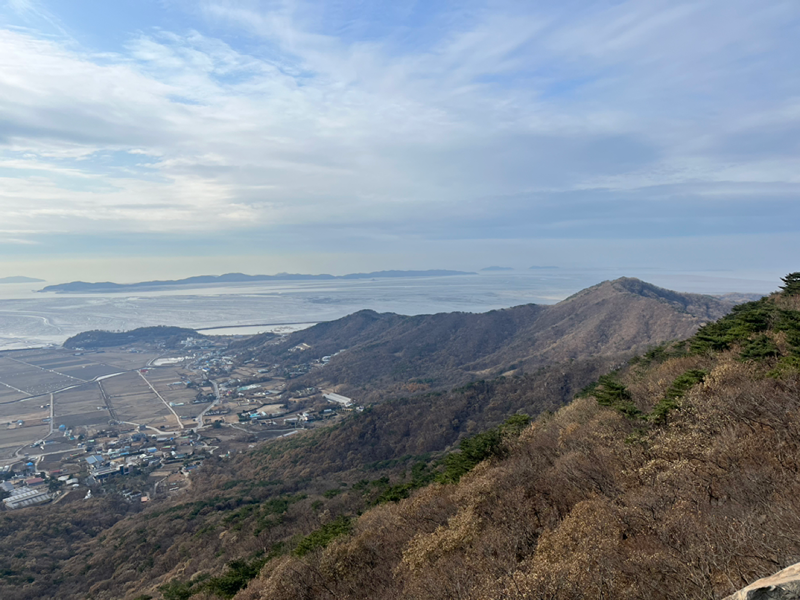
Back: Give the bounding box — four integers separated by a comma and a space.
39, 270, 475, 294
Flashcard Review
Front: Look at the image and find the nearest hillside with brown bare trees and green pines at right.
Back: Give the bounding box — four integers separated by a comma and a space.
234, 274, 800, 600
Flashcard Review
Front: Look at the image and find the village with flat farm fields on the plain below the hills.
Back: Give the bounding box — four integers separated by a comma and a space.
0, 336, 361, 510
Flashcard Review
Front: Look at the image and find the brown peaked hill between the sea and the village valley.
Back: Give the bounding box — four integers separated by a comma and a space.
238, 278, 733, 399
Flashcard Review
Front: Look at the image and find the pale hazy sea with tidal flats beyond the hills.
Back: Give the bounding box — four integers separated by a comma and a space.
0, 268, 780, 350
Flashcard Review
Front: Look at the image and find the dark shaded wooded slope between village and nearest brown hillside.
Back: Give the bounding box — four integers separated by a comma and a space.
0, 359, 611, 600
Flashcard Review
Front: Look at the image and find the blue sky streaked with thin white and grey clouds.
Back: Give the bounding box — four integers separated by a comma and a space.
0, 0, 800, 281
